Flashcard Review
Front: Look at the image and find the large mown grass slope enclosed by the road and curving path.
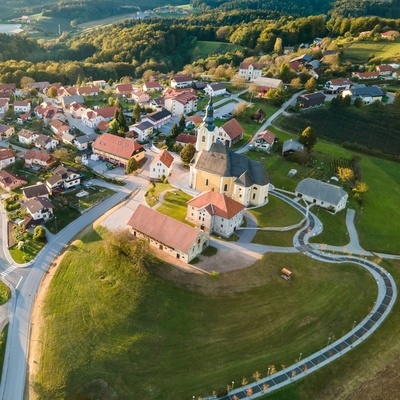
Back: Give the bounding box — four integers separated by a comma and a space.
32, 231, 376, 400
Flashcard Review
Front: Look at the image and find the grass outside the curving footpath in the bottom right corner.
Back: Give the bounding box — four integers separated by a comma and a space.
262, 260, 400, 400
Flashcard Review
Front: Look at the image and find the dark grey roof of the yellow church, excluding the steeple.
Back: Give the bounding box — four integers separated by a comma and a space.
194, 140, 269, 187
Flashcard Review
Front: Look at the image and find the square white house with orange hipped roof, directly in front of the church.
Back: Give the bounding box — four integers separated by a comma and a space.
186, 190, 245, 238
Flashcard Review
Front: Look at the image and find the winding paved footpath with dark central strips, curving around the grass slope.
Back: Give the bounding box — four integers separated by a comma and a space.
216, 191, 397, 400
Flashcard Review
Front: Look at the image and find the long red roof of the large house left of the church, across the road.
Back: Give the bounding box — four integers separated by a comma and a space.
92, 133, 144, 160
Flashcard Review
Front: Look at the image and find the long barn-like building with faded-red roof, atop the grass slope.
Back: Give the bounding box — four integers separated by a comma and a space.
128, 204, 209, 263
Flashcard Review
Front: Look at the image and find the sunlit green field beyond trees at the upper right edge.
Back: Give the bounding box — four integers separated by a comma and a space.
343, 39, 400, 64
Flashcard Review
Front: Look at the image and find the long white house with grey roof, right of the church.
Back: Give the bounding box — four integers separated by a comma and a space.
295, 178, 349, 214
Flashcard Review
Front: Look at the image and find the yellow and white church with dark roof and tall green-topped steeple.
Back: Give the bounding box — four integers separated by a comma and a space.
189, 98, 269, 207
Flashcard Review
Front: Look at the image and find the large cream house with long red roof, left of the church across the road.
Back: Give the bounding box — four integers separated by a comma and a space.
92, 133, 145, 167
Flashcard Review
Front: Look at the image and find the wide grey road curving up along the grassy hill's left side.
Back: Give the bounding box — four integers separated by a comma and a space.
0, 187, 130, 400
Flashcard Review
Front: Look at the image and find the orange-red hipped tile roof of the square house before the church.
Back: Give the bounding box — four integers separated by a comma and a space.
187, 190, 246, 219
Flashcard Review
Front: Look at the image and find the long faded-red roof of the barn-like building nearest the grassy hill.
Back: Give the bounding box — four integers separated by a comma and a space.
128, 204, 201, 254
